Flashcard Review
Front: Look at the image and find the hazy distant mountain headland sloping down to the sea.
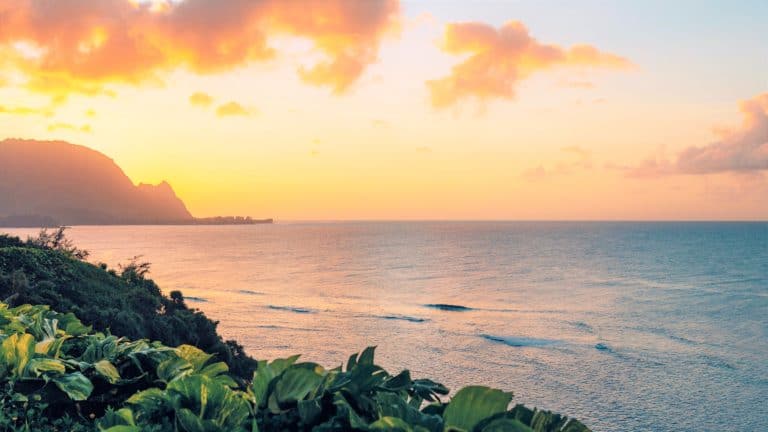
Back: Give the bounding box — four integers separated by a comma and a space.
0, 139, 273, 227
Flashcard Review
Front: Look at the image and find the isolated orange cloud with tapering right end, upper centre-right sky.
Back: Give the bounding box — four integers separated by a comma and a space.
426, 21, 632, 108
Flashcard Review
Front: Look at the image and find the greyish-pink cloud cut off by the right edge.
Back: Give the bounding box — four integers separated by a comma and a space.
676, 93, 768, 174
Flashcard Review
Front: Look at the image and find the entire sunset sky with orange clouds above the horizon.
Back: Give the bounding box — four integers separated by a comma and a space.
0, 0, 768, 220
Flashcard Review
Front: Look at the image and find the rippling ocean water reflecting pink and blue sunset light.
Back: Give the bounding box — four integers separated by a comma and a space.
1, 222, 768, 431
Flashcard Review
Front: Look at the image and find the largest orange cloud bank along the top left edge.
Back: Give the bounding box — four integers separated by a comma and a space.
0, 0, 400, 94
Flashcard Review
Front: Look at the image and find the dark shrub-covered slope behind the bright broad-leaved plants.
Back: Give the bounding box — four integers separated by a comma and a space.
0, 233, 256, 380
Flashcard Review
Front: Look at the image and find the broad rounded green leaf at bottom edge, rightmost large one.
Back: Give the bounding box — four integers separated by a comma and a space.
443, 386, 512, 432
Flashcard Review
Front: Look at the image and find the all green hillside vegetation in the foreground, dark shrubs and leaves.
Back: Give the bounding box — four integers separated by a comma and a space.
0, 231, 589, 432
